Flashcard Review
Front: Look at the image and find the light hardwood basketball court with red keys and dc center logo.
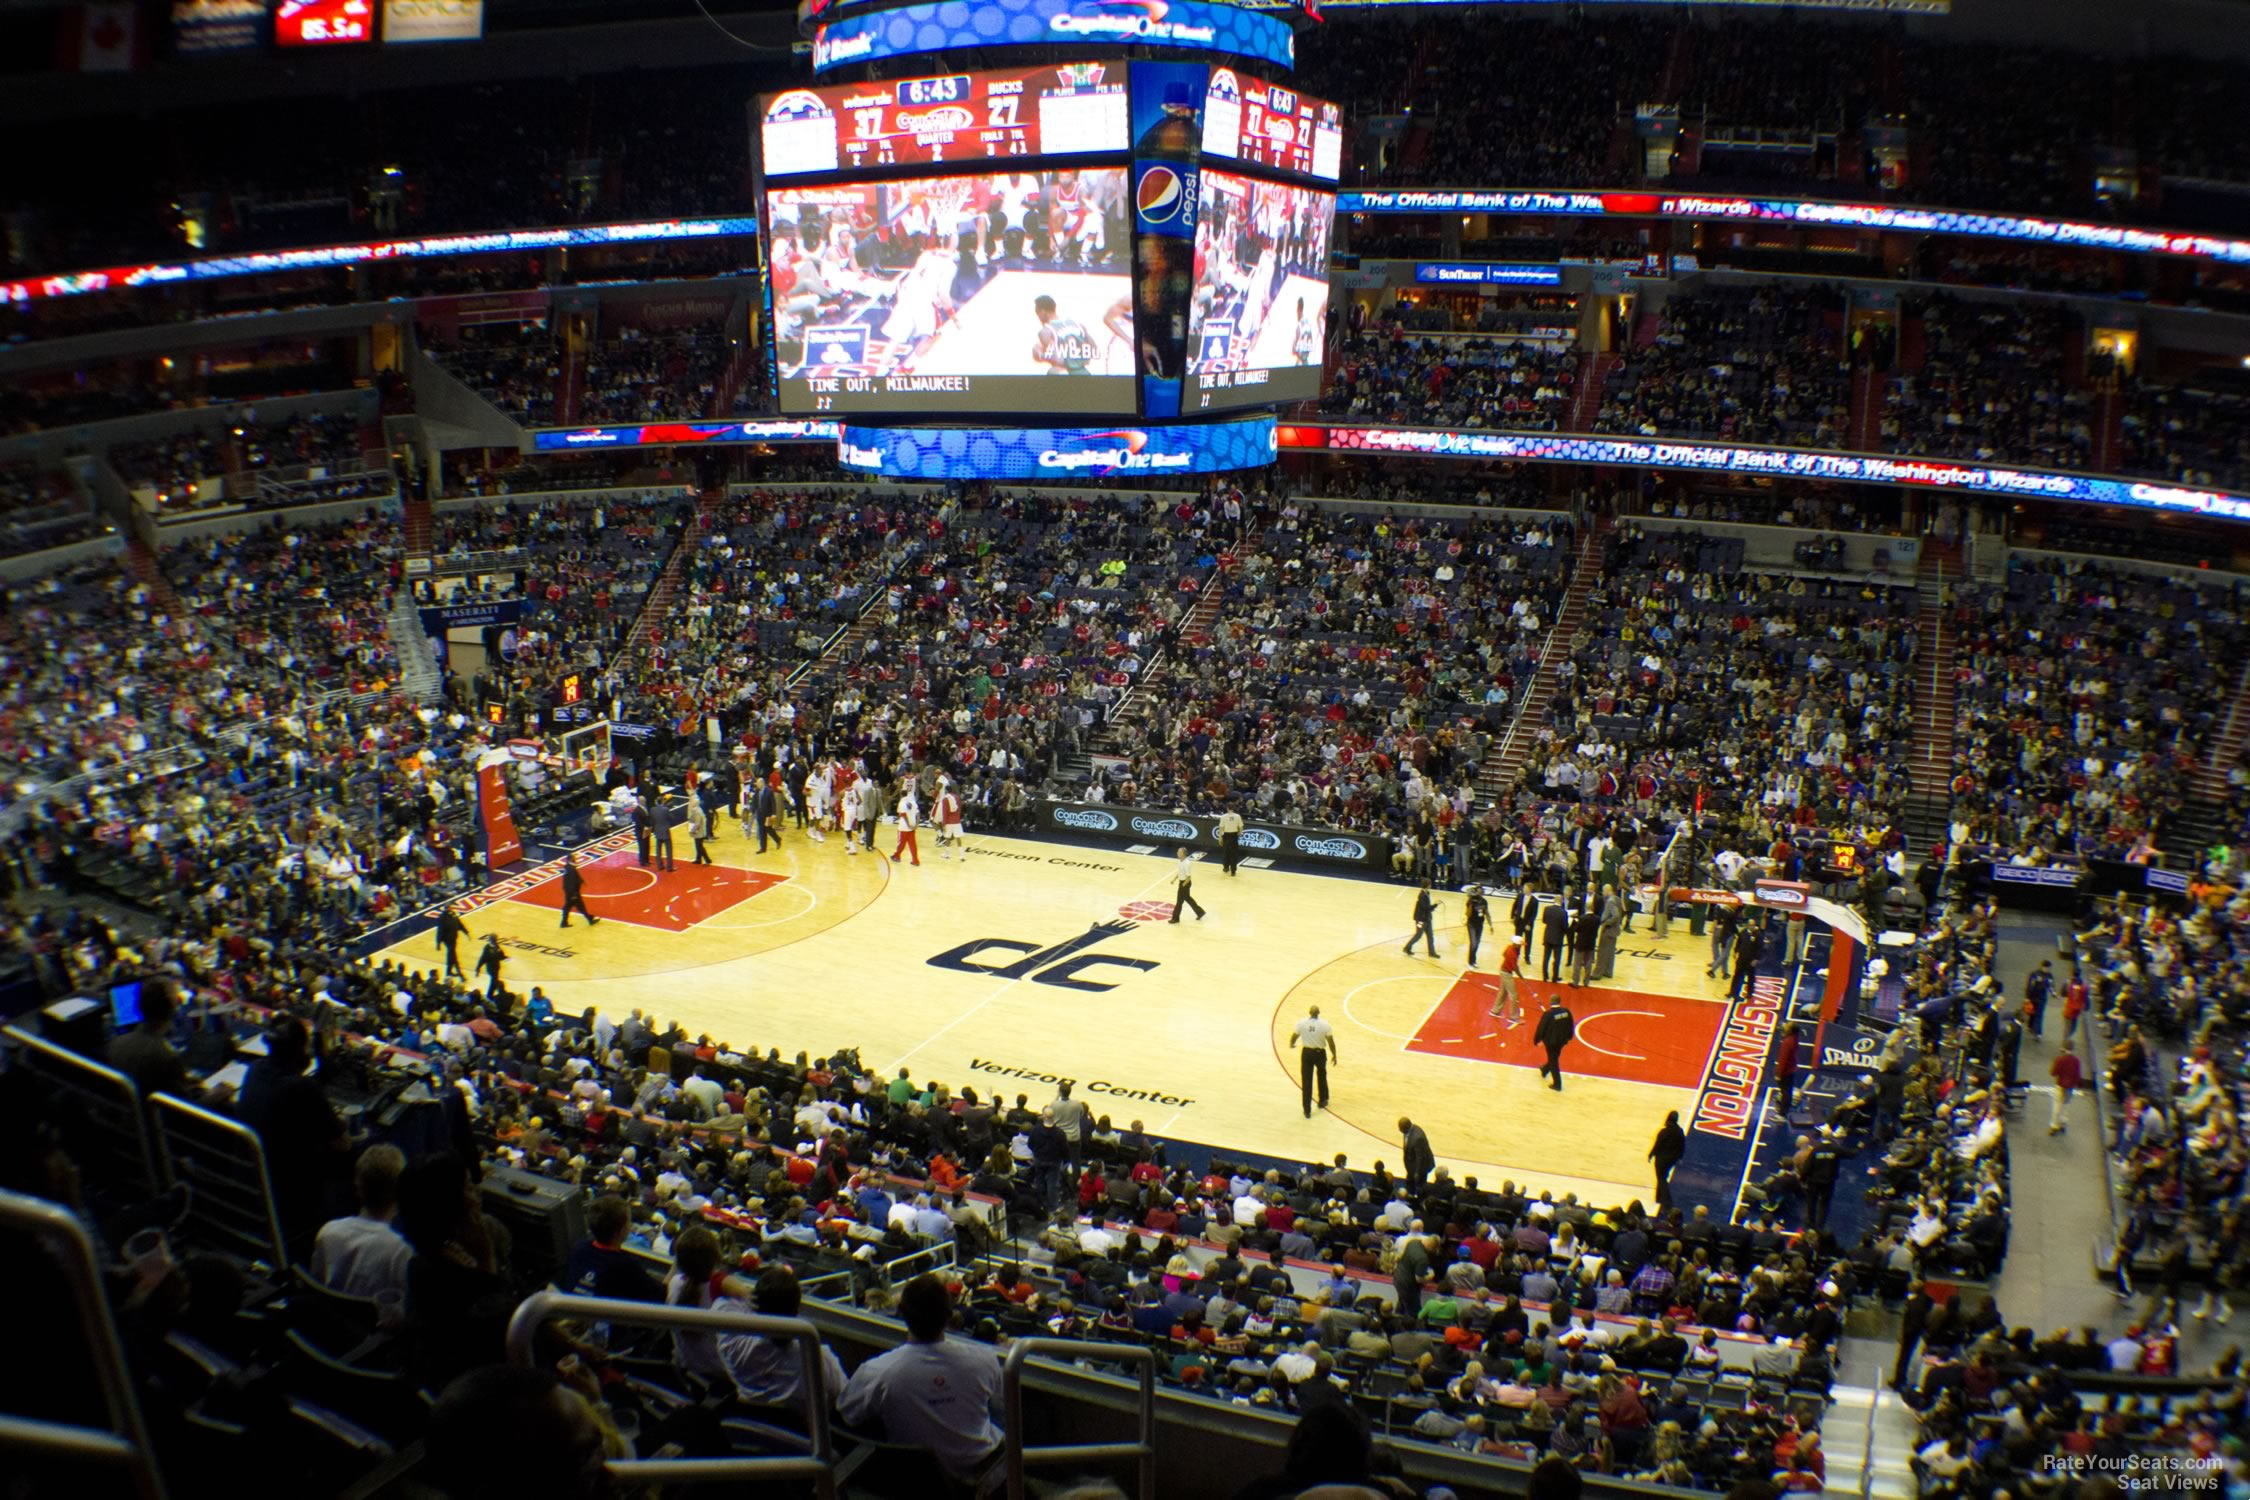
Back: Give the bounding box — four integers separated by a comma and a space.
387, 821, 1726, 1201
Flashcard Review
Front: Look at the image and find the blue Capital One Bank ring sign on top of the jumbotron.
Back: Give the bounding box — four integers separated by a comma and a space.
812, 0, 1296, 72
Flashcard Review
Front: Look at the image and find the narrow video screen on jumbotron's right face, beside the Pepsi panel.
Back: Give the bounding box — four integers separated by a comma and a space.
1181, 166, 1337, 412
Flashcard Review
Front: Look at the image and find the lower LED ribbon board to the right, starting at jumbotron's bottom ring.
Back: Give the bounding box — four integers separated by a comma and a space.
1276, 425, 2250, 522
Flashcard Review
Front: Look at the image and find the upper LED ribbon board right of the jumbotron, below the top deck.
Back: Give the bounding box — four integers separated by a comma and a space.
1337, 187, 2250, 265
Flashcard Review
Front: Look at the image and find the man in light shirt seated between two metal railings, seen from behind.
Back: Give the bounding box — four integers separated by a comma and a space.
837, 1275, 1001, 1480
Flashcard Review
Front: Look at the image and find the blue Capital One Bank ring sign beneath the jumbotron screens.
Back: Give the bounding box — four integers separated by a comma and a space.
837, 416, 1274, 479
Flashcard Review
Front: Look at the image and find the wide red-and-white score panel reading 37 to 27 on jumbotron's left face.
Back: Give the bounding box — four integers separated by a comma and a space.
758, 63, 1130, 178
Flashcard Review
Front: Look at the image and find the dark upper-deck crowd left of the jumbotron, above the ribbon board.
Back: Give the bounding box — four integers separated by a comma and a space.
0, 58, 765, 274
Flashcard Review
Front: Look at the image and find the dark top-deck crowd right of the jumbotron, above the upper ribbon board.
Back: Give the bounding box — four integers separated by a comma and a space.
1303, 13, 2250, 231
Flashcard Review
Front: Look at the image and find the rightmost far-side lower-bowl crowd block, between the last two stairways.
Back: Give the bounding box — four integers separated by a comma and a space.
1953, 560, 2246, 864
